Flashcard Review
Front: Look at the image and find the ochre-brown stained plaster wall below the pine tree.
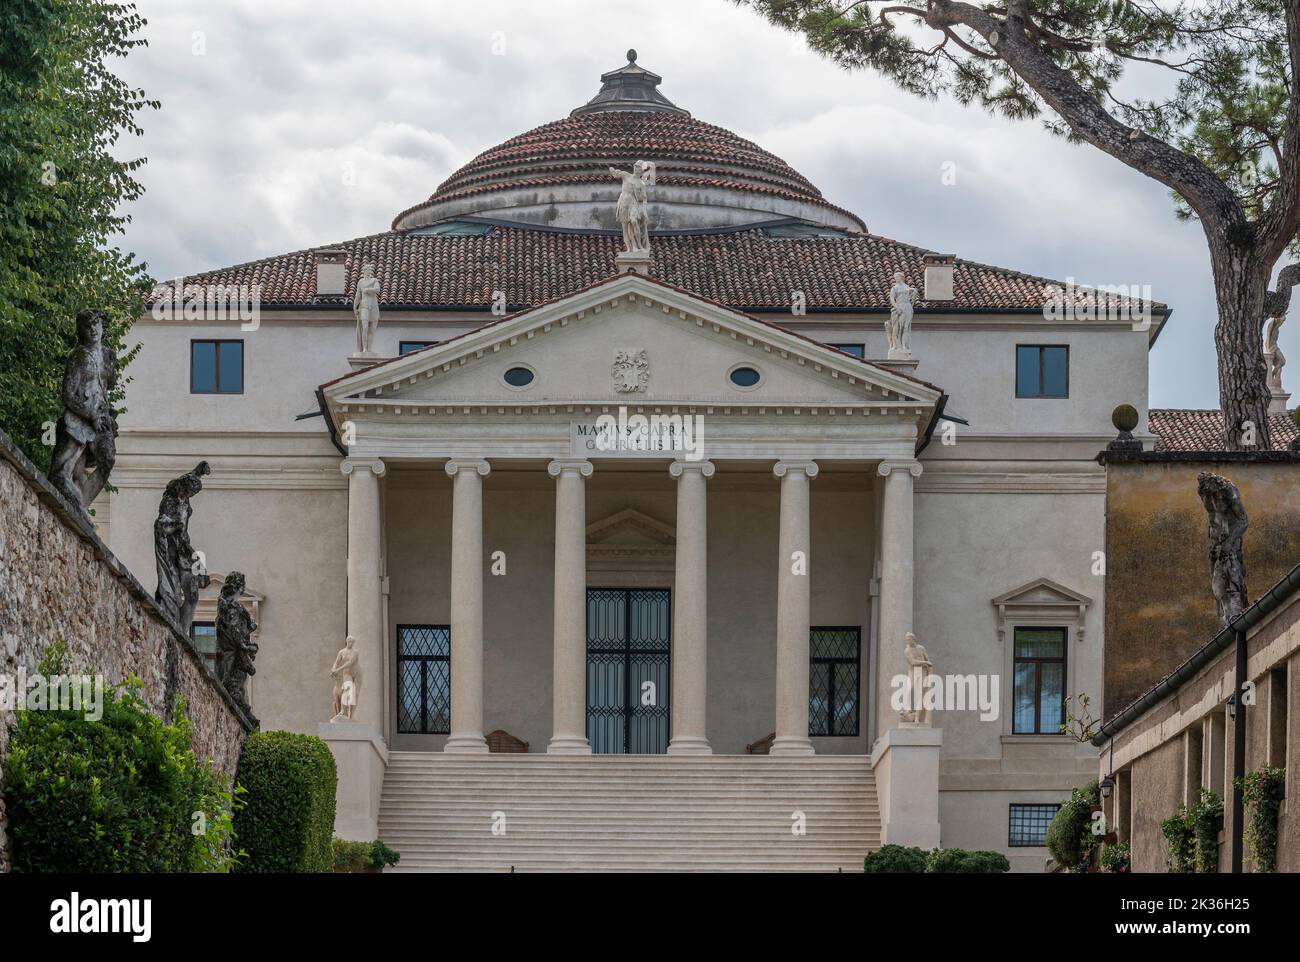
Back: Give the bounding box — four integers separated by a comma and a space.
1104, 452, 1300, 718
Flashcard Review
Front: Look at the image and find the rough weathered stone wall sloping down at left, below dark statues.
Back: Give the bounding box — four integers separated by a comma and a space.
0, 433, 251, 871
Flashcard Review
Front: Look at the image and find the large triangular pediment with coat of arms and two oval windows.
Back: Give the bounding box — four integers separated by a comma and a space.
322, 274, 941, 416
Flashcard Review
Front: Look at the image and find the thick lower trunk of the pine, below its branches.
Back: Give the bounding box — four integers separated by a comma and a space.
1209, 238, 1273, 451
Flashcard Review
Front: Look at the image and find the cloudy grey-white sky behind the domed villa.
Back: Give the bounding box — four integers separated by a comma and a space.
120, 0, 1279, 407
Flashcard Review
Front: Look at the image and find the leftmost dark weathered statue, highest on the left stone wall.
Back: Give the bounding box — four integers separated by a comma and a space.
49, 311, 117, 512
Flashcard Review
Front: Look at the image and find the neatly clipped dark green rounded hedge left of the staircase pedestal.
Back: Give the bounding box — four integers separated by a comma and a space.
234, 732, 338, 872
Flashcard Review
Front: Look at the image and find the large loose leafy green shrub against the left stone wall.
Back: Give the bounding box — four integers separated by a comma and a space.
5, 645, 235, 872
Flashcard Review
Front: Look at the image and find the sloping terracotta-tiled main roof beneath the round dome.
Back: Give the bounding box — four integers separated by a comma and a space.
167, 226, 1161, 311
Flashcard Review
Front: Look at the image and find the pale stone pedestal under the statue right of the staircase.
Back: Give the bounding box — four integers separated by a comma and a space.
871, 724, 944, 850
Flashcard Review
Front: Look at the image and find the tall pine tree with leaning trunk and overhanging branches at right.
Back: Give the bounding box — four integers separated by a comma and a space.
735, 0, 1300, 450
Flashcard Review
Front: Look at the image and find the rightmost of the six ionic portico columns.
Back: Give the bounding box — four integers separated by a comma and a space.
876, 460, 920, 736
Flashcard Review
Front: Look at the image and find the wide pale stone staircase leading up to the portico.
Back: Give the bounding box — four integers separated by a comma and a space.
380, 751, 880, 872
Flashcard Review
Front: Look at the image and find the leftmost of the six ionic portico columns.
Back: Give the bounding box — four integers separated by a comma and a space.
339, 458, 385, 735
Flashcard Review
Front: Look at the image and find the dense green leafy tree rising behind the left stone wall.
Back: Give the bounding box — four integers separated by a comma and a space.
0, 0, 157, 468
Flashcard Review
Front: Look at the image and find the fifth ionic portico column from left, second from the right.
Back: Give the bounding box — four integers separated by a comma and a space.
771, 462, 818, 755
